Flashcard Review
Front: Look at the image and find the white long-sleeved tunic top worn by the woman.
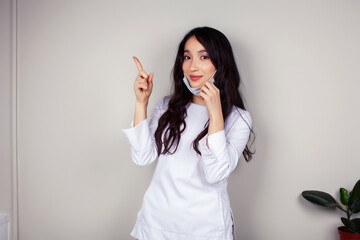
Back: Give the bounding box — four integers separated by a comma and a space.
123, 97, 252, 240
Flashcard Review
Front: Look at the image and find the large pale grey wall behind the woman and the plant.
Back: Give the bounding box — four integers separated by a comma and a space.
10, 0, 360, 240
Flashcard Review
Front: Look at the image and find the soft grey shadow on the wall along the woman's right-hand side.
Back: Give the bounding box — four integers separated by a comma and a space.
228, 41, 264, 240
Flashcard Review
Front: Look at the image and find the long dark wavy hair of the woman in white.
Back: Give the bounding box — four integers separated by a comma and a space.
155, 27, 255, 161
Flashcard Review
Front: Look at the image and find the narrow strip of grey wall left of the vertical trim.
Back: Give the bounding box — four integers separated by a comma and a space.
0, 0, 16, 237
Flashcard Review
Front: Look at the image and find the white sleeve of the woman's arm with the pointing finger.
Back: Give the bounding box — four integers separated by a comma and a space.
122, 100, 163, 166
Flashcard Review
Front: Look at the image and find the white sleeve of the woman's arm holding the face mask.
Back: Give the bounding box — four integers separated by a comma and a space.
199, 111, 252, 184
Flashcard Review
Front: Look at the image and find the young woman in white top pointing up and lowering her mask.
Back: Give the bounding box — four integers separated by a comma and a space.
123, 27, 253, 240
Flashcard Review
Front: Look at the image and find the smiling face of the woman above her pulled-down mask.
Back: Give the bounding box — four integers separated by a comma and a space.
182, 36, 216, 88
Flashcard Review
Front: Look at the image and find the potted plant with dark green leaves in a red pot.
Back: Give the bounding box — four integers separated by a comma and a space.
301, 180, 360, 240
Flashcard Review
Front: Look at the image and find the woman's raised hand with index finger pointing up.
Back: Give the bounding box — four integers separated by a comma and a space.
133, 57, 154, 104
